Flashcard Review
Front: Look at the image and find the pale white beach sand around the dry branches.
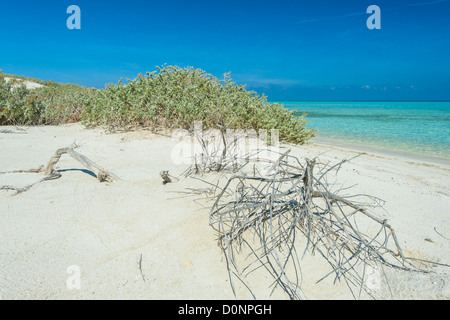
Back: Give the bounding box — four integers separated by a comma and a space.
0, 124, 450, 299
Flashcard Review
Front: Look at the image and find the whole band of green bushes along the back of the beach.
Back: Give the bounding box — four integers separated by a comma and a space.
0, 66, 314, 143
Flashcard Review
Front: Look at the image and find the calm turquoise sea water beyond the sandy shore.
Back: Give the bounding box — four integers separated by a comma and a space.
279, 101, 450, 160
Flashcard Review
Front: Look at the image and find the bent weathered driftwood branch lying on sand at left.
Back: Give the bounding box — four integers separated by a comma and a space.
0, 148, 120, 195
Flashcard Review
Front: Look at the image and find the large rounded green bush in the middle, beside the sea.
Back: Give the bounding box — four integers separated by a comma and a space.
84, 66, 314, 143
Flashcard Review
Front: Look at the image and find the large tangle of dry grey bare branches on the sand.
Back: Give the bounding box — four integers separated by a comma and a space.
178, 128, 442, 299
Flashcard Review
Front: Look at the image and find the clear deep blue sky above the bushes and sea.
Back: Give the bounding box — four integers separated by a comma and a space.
0, 0, 450, 100
